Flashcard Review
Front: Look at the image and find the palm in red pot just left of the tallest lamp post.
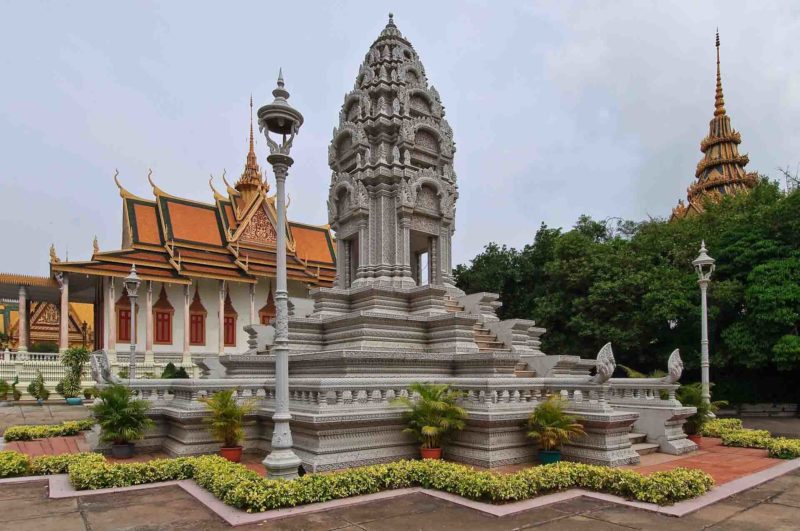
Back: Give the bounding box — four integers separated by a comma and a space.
202, 389, 255, 463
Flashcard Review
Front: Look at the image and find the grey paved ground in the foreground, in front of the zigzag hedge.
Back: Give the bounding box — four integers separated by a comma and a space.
0, 471, 800, 531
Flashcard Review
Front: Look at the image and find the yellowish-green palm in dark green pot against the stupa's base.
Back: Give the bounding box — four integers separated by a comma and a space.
528, 395, 586, 465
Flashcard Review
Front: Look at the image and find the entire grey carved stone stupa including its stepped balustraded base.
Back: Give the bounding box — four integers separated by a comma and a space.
96, 15, 696, 471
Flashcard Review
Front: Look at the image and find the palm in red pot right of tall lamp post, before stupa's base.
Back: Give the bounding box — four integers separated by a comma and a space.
393, 382, 467, 459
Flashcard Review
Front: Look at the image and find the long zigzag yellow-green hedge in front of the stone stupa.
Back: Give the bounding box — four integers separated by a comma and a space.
62, 456, 714, 512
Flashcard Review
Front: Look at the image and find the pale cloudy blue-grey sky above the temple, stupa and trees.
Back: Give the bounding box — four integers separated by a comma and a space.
0, 0, 800, 275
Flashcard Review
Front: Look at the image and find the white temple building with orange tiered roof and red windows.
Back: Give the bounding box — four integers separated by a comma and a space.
0, 100, 336, 365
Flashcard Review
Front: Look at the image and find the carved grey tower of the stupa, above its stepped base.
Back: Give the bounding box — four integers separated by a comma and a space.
328, 12, 458, 293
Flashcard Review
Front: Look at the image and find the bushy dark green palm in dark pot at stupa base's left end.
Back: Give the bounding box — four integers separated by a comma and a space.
92, 384, 153, 459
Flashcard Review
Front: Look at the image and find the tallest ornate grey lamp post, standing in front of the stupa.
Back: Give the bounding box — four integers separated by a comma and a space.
258, 68, 303, 479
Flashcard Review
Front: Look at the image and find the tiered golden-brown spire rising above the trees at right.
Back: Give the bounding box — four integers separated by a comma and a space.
670, 33, 758, 220
